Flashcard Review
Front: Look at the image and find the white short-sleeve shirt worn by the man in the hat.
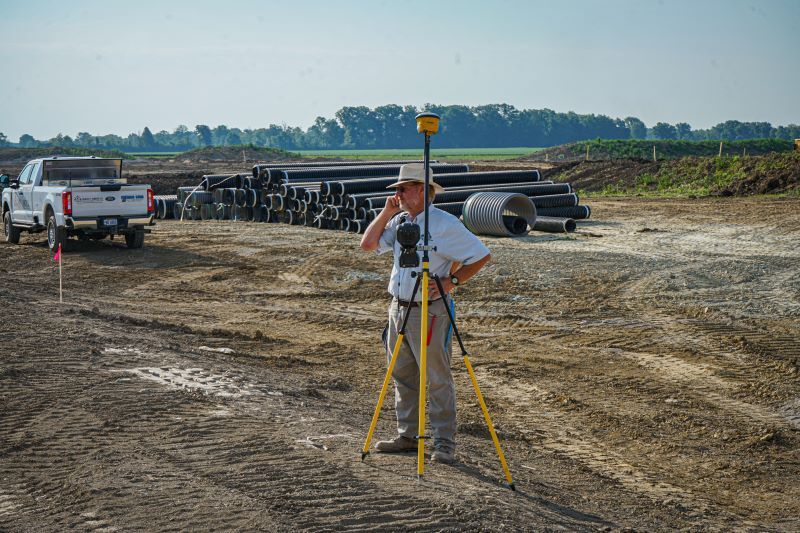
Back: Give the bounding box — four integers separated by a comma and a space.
377, 206, 489, 302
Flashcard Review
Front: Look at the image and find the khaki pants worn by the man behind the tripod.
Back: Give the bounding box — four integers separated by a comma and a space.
386, 298, 456, 450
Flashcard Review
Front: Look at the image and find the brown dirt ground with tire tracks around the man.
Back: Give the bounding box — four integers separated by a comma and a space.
0, 198, 800, 531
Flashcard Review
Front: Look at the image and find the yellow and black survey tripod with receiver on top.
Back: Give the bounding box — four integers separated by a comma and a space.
361, 113, 516, 490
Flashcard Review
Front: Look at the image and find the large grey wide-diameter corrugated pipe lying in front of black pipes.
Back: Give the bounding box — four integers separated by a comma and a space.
462, 192, 536, 237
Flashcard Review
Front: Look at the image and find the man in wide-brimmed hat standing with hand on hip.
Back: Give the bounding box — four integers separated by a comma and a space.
361, 163, 491, 463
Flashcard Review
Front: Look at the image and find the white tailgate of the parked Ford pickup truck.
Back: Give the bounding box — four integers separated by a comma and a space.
72, 186, 147, 218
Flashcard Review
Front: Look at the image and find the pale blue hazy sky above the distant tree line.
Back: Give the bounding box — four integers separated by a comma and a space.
0, 0, 800, 142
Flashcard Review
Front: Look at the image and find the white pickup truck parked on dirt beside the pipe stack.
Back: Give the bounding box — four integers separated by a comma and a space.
2, 157, 155, 253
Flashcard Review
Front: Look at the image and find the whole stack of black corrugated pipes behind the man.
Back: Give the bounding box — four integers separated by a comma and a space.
167, 161, 591, 233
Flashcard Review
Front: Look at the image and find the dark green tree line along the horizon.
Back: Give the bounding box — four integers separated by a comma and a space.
0, 104, 800, 152
